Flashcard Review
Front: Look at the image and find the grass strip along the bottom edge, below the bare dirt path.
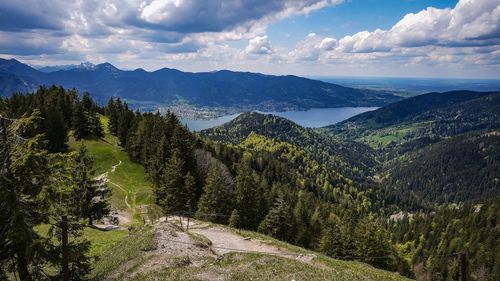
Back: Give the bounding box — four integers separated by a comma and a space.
118, 253, 414, 281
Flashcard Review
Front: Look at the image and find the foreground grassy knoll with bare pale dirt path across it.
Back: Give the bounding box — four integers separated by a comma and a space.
96, 217, 410, 281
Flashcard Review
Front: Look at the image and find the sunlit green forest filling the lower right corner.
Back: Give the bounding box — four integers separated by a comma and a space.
388, 199, 500, 280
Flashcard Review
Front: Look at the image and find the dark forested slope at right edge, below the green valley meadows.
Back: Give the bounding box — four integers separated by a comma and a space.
384, 131, 500, 204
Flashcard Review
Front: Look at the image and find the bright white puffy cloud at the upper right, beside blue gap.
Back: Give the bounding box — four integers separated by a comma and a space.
339, 0, 500, 52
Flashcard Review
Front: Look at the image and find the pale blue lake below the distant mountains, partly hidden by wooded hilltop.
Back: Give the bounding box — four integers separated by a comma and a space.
182, 107, 378, 131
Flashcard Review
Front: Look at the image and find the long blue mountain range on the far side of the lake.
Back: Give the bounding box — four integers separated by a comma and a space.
0, 59, 400, 110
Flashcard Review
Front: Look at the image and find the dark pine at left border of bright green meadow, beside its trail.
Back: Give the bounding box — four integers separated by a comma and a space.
72, 145, 111, 225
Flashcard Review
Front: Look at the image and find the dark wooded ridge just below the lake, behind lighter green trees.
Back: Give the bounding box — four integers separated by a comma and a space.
202, 112, 377, 179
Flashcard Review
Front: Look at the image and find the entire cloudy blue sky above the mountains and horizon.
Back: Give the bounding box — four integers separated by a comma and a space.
0, 0, 500, 78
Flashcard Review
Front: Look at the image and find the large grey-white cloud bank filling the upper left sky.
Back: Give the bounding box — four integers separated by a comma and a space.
0, 0, 341, 53
